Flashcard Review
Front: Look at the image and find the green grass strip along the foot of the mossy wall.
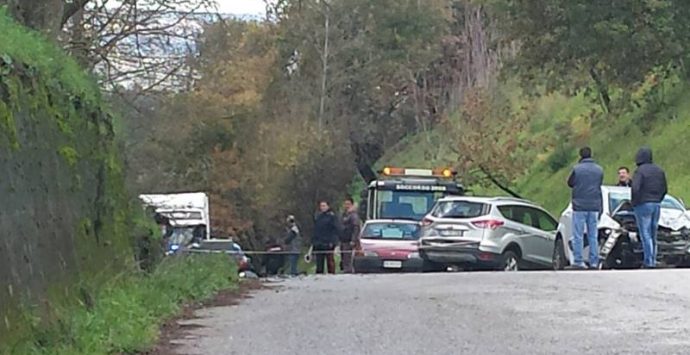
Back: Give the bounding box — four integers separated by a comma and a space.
0, 255, 238, 355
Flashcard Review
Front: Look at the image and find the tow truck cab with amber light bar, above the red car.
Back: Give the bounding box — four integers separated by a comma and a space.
360, 167, 464, 221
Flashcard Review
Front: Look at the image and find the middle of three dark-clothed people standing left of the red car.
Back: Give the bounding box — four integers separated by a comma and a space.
311, 201, 340, 274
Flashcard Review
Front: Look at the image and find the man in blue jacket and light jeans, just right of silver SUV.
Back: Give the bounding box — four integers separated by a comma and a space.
568, 147, 604, 269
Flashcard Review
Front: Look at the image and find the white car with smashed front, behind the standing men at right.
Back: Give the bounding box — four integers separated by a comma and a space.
552, 186, 690, 270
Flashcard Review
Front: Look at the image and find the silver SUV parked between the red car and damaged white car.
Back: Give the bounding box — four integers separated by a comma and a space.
419, 196, 558, 271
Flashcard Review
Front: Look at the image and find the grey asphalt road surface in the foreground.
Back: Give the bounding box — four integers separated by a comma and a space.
173, 270, 690, 355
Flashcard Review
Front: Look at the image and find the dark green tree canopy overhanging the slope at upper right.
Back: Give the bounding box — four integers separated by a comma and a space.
485, 0, 690, 94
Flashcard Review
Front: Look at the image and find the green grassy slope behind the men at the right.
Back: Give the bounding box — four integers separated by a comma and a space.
380, 78, 690, 215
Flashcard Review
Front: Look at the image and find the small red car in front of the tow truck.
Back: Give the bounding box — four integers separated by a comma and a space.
354, 219, 423, 273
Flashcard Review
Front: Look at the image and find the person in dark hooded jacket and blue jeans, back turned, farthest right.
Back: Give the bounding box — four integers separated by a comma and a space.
630, 147, 668, 268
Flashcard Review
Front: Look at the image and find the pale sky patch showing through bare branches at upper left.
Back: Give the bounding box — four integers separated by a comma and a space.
60, 0, 218, 91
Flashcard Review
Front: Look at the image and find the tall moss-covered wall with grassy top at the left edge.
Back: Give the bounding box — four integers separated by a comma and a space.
0, 8, 134, 342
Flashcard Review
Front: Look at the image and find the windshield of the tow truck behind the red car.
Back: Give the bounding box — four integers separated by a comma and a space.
376, 190, 443, 221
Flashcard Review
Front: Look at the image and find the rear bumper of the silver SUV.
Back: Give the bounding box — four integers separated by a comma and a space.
419, 246, 501, 267
